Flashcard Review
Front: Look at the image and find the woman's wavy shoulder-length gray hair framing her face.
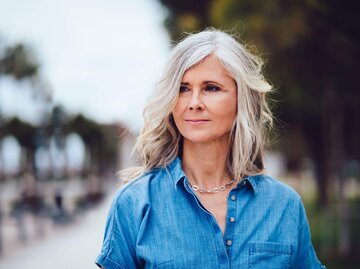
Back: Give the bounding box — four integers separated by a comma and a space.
120, 29, 272, 180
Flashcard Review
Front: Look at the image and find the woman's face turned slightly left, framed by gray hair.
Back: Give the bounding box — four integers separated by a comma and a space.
173, 55, 237, 143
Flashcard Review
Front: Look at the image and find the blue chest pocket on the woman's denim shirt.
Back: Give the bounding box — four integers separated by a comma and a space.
249, 242, 291, 269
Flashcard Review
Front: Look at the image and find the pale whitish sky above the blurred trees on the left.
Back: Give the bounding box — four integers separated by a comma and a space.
0, 0, 169, 130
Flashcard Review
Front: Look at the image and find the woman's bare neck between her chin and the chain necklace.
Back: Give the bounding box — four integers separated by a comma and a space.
182, 139, 231, 188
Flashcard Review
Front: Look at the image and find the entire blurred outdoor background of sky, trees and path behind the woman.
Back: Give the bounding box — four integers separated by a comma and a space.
0, 0, 360, 269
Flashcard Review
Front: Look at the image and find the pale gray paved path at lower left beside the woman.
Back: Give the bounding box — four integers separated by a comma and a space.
0, 194, 113, 269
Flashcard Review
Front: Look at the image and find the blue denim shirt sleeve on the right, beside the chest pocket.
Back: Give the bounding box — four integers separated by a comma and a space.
295, 200, 326, 269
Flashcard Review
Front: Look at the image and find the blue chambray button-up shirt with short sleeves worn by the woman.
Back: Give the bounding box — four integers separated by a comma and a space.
96, 158, 325, 269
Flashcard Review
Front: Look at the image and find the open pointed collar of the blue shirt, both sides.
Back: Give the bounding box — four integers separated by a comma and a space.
166, 156, 261, 194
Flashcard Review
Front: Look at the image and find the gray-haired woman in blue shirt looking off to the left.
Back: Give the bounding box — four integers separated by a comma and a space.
96, 30, 325, 269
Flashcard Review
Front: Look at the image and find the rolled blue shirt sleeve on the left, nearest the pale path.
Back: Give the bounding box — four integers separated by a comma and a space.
95, 191, 139, 269
